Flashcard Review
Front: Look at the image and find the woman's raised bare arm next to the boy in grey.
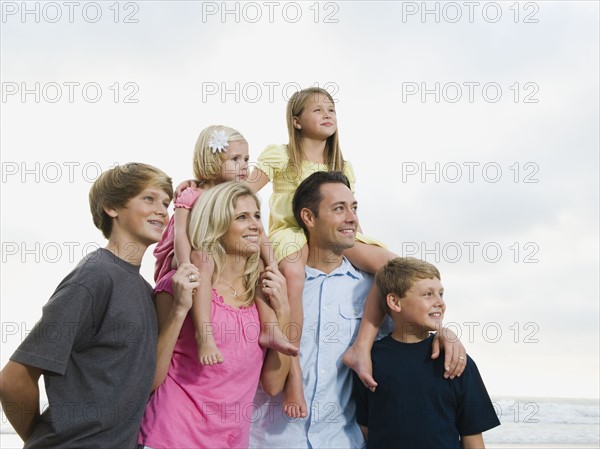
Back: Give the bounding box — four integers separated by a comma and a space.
152, 263, 200, 391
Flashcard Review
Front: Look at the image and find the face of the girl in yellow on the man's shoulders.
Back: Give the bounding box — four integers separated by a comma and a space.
293, 93, 337, 140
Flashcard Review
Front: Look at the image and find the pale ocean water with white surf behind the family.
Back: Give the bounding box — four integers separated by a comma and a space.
0, 397, 600, 449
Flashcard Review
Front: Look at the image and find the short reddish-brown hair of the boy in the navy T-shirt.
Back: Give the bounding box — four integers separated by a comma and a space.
375, 257, 442, 314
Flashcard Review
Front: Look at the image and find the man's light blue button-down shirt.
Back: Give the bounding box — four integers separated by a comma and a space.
250, 258, 373, 449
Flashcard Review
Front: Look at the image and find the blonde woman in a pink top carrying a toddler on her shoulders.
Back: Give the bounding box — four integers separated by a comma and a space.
139, 182, 289, 449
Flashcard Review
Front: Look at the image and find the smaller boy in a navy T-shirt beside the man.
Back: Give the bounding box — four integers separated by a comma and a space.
354, 258, 500, 449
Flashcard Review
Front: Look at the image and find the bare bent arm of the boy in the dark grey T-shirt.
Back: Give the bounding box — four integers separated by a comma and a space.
0, 360, 43, 441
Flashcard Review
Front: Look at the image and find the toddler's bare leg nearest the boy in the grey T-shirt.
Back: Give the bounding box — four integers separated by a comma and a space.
190, 251, 223, 365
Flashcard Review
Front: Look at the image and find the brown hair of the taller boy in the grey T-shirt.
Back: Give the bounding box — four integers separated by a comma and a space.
89, 162, 173, 239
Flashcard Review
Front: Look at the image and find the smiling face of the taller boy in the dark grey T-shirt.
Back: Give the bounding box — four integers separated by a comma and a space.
105, 186, 171, 251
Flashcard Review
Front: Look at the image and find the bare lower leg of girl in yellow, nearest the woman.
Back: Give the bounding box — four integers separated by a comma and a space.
279, 245, 308, 418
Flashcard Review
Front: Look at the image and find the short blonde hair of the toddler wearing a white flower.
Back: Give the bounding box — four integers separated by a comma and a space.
193, 125, 246, 182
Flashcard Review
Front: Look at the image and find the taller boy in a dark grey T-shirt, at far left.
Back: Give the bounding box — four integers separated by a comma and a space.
0, 163, 198, 448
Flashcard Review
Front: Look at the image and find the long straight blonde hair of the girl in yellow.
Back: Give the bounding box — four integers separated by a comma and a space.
286, 87, 344, 176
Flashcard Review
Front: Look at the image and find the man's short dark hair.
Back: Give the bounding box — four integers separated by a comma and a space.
292, 171, 350, 237
